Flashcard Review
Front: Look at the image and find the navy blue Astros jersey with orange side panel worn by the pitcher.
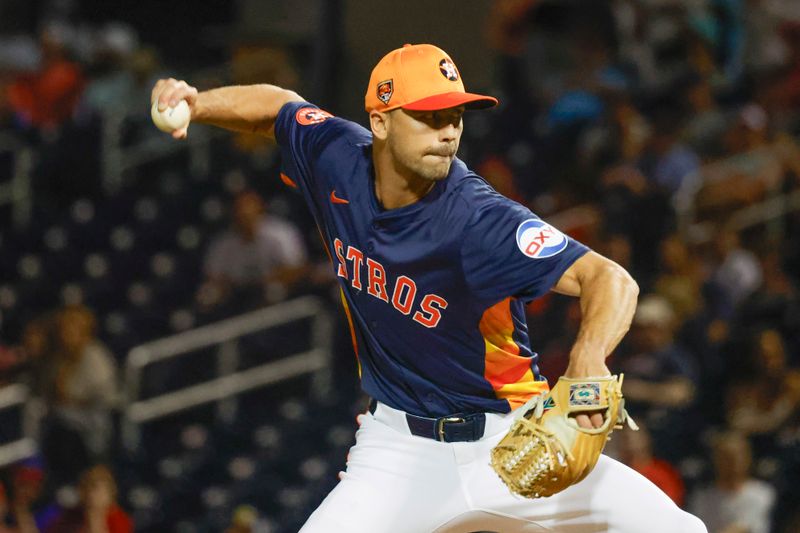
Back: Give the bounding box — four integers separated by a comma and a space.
275, 102, 587, 417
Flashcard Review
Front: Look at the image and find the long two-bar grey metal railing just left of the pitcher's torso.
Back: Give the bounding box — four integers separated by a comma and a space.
122, 296, 332, 451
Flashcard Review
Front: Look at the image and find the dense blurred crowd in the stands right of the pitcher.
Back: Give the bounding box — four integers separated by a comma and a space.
482, 0, 800, 532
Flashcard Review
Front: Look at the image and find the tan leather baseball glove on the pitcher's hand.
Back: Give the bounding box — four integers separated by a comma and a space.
491, 375, 638, 498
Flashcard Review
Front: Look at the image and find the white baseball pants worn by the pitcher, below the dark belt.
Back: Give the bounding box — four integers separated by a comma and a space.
301, 403, 706, 533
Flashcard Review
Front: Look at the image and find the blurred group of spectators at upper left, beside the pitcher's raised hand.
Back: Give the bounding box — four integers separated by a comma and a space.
0, 20, 160, 209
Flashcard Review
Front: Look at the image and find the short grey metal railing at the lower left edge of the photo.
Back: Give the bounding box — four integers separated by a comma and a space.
0, 383, 42, 466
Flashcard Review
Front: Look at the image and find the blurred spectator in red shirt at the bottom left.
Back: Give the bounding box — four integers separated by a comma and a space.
42, 465, 133, 533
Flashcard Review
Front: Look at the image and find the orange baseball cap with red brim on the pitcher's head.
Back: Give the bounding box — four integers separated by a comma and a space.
364, 44, 497, 112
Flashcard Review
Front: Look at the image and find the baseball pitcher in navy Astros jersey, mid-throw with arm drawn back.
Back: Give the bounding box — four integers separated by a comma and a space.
152, 44, 706, 533
